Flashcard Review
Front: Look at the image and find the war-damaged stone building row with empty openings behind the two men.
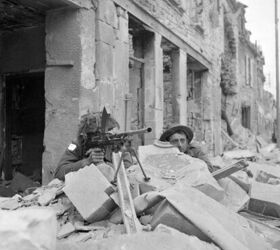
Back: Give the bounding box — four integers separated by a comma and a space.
0, 0, 274, 186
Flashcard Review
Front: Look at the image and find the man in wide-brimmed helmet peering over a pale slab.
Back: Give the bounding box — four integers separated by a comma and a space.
159, 125, 215, 173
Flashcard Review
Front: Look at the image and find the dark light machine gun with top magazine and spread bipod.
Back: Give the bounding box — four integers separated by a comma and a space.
85, 107, 152, 184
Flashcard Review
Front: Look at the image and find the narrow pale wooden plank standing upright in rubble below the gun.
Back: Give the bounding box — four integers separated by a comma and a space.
113, 153, 141, 234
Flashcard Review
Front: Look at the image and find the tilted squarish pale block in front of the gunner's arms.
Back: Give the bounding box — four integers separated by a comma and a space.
63, 164, 116, 222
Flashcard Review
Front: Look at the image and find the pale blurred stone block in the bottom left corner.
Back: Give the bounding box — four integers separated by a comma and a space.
0, 208, 57, 250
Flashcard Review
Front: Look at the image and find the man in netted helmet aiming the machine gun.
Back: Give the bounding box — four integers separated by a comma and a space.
55, 112, 132, 180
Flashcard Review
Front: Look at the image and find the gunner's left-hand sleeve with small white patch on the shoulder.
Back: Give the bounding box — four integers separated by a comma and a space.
55, 143, 88, 180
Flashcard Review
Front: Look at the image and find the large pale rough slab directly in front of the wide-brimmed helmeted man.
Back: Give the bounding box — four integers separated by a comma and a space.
133, 143, 224, 200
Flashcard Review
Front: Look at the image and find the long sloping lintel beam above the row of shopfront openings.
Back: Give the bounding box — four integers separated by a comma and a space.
113, 0, 212, 69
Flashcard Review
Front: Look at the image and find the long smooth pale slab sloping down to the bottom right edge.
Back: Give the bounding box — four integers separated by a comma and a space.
159, 186, 271, 250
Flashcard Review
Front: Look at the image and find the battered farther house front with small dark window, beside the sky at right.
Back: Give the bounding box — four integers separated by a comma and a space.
221, 3, 272, 150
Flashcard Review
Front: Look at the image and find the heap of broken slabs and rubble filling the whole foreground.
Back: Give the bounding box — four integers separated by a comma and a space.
0, 142, 280, 250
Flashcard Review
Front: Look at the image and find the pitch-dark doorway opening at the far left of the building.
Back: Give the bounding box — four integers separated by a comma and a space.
3, 72, 45, 182
